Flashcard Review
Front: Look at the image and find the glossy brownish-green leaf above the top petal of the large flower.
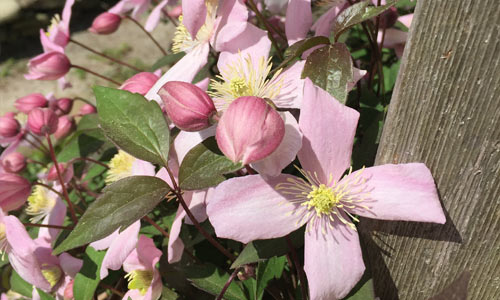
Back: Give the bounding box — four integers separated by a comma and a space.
302, 43, 354, 104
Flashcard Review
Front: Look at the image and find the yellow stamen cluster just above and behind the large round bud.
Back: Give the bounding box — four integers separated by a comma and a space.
209, 53, 284, 110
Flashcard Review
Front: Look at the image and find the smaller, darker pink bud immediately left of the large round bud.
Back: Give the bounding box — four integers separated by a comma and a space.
158, 81, 217, 131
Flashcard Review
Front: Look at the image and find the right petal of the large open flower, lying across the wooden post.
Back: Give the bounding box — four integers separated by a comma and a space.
339, 163, 446, 224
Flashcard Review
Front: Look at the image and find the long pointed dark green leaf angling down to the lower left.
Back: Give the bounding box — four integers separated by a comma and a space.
54, 176, 170, 254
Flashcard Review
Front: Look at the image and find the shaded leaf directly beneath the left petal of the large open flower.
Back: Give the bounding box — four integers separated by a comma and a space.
231, 229, 304, 269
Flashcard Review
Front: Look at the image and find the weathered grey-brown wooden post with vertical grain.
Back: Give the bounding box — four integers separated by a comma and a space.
360, 0, 500, 300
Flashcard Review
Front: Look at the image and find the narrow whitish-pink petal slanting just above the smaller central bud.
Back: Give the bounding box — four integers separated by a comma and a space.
145, 44, 210, 103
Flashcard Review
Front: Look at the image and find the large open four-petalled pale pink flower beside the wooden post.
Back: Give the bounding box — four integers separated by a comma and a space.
207, 79, 446, 300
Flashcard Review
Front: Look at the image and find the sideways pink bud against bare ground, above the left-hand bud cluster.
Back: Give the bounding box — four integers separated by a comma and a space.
24, 51, 71, 80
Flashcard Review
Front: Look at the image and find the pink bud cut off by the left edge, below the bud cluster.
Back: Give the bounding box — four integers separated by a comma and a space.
0, 173, 31, 212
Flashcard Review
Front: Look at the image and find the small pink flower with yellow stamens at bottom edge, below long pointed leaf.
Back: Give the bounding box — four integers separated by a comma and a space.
123, 235, 162, 300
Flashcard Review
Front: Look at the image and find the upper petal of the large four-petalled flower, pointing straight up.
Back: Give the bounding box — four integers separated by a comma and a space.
298, 78, 359, 183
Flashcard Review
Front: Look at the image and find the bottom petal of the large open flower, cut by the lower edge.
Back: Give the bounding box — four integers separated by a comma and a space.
304, 221, 365, 300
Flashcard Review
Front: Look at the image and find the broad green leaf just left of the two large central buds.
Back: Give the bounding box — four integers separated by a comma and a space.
94, 86, 170, 165
